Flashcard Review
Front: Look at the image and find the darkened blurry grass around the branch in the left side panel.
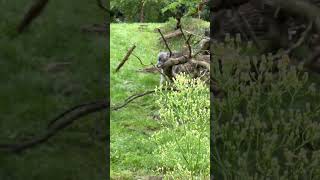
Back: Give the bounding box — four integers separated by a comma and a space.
0, 0, 107, 180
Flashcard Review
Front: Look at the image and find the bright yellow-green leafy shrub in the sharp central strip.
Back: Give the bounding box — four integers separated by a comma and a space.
151, 75, 210, 179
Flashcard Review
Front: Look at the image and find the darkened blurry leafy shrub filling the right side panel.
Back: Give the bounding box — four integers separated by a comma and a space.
212, 35, 320, 179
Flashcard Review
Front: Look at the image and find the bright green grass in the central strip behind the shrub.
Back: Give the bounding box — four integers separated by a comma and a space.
110, 19, 209, 179
